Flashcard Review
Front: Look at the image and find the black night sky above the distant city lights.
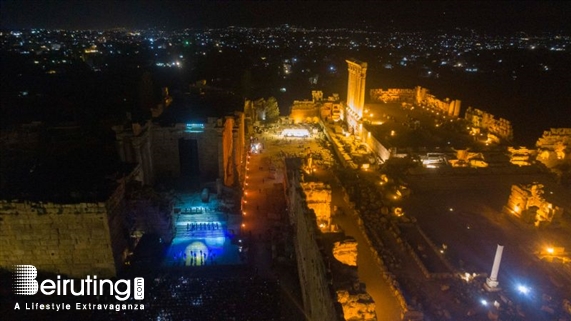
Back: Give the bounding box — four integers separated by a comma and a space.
0, 0, 571, 32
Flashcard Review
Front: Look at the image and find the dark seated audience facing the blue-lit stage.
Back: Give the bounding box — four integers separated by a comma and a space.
144, 272, 280, 321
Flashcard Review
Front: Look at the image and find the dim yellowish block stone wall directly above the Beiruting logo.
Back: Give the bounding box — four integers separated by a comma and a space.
0, 201, 116, 277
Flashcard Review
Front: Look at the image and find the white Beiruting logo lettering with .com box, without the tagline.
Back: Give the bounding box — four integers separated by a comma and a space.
14, 265, 145, 301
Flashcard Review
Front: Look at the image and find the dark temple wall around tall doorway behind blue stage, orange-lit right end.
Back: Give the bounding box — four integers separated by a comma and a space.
113, 115, 247, 185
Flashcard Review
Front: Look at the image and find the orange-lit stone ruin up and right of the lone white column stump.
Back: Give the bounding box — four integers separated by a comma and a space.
504, 183, 563, 226
